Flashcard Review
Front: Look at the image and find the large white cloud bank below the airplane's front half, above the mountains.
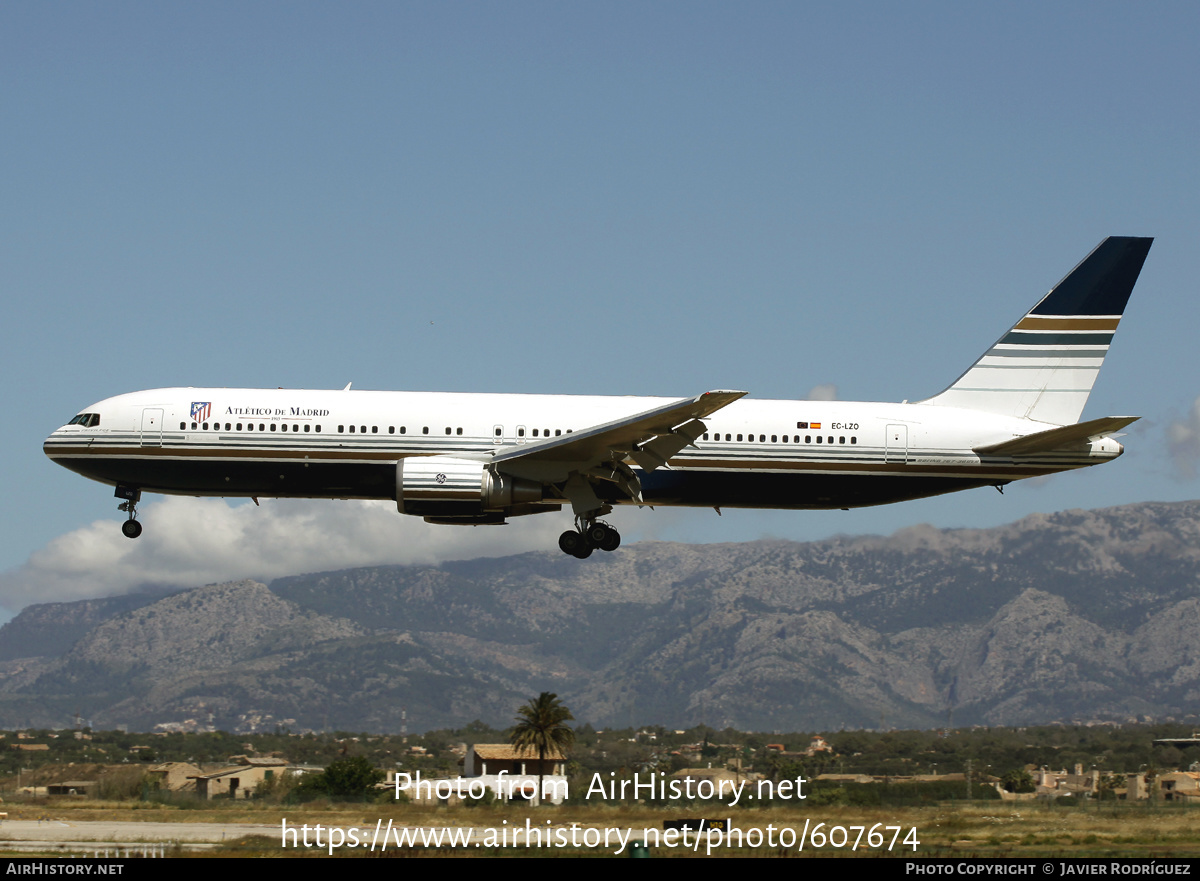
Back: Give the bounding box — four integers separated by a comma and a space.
0, 497, 570, 612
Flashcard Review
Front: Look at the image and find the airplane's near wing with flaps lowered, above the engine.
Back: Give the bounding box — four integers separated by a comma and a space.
492, 390, 746, 484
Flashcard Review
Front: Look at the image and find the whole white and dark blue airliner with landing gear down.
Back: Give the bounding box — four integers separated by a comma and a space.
43, 236, 1153, 559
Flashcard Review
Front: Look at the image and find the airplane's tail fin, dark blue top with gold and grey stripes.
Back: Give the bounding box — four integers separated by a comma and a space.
922, 235, 1154, 425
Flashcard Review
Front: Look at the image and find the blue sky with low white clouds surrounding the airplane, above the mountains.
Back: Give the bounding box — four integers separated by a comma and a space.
0, 2, 1200, 609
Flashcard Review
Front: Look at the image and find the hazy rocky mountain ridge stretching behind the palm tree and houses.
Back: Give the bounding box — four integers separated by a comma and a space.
0, 502, 1200, 731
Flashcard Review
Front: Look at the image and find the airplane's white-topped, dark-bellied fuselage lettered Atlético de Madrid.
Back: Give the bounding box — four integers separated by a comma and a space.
44, 388, 1122, 514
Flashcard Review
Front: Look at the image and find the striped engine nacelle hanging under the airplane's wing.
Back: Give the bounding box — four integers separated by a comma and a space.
396, 456, 542, 519
